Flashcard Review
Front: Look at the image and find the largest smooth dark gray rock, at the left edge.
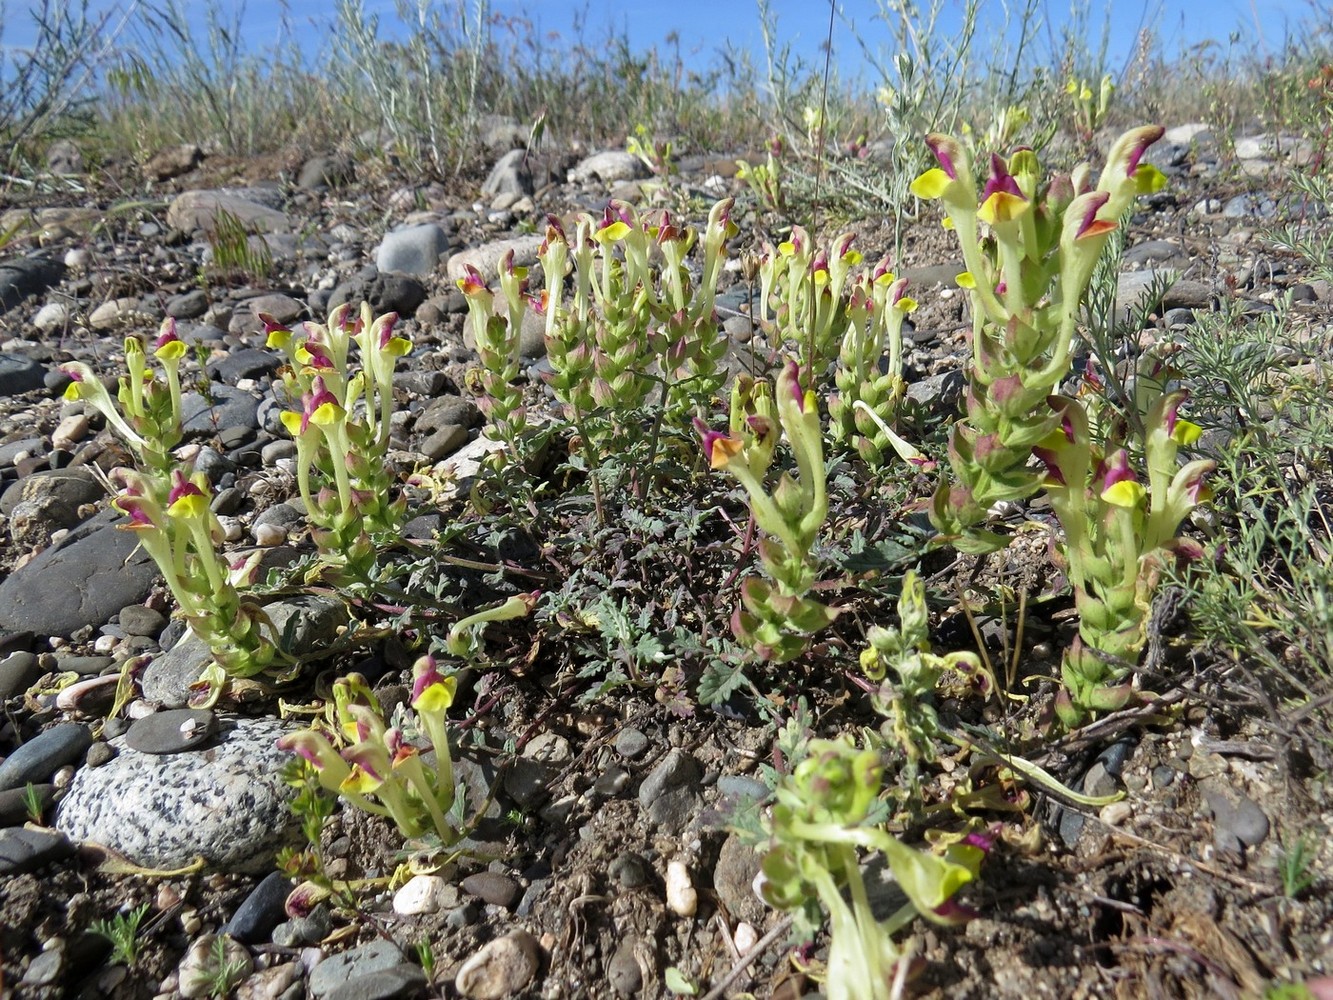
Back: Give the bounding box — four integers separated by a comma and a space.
0, 509, 157, 636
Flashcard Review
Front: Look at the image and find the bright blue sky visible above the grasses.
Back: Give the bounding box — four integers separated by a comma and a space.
0, 0, 1330, 77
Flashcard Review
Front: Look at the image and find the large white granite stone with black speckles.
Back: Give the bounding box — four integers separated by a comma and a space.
55, 719, 296, 872
